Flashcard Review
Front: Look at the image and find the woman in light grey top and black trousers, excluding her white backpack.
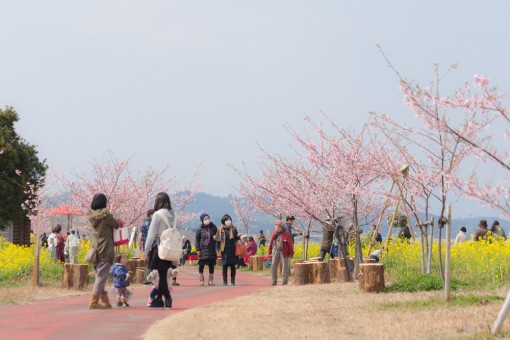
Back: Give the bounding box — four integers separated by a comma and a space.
145, 192, 180, 309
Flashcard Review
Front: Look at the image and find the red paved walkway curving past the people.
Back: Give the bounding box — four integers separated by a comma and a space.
0, 269, 271, 340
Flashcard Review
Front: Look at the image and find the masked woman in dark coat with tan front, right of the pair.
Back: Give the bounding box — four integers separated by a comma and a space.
216, 214, 239, 286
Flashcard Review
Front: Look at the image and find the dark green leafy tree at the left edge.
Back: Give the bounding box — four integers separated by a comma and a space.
0, 107, 47, 228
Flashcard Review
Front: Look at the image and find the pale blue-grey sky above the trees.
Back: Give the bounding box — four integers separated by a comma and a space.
0, 0, 510, 217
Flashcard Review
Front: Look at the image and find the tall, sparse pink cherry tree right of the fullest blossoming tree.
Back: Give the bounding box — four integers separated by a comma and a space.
374, 49, 490, 282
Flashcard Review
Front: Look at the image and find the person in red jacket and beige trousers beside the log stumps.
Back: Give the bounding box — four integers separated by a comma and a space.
268, 221, 294, 286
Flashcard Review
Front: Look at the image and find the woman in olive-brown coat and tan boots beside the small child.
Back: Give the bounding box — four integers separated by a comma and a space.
87, 194, 117, 309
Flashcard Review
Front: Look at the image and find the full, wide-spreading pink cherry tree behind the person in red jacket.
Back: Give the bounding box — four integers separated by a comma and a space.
233, 118, 393, 274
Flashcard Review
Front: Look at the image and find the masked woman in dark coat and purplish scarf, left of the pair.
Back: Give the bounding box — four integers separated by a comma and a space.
195, 214, 218, 286
